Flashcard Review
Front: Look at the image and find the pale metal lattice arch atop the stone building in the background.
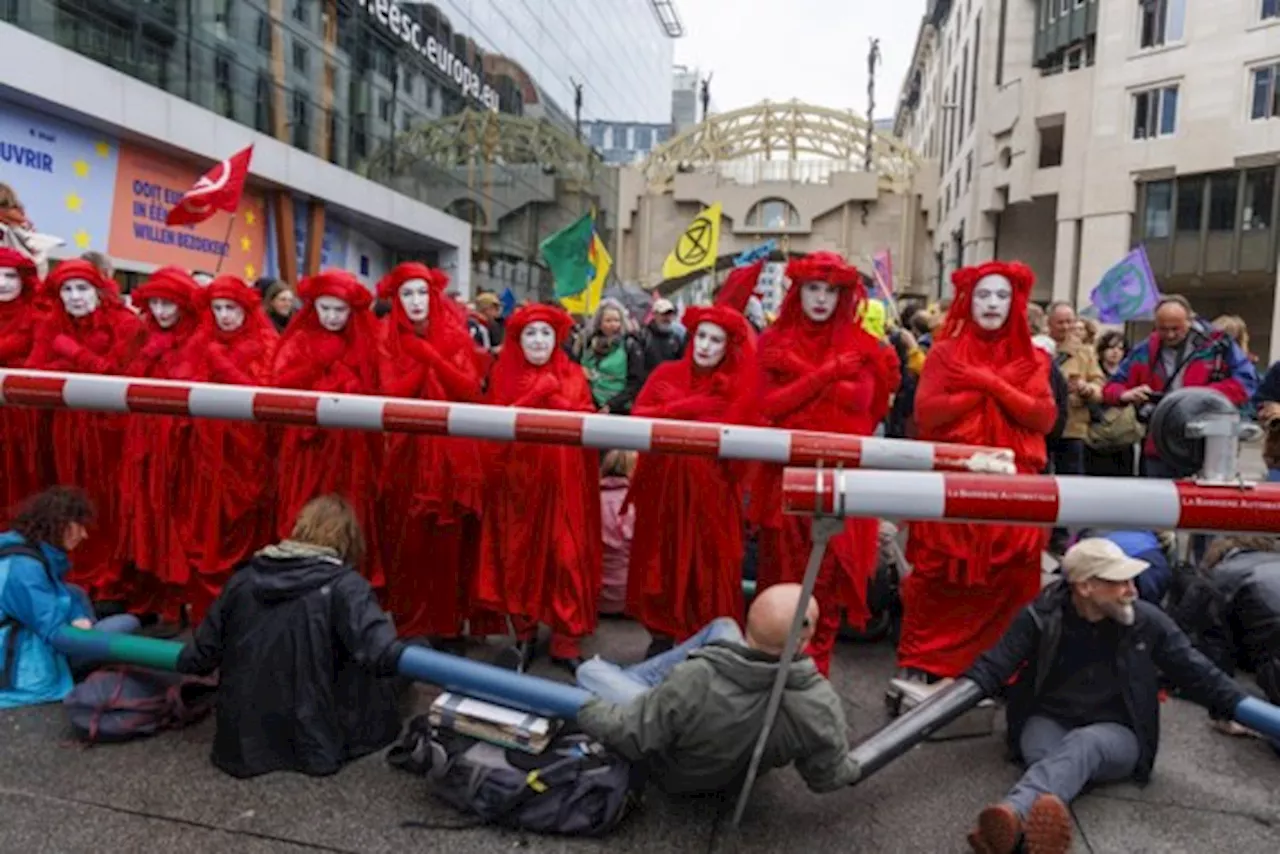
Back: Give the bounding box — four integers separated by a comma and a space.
643, 101, 919, 192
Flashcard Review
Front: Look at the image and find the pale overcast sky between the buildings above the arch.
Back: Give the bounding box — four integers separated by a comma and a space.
676, 0, 925, 118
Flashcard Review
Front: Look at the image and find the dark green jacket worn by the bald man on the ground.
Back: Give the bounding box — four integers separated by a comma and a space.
577, 641, 858, 794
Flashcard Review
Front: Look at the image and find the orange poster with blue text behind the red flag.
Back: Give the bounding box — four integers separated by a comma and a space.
108, 142, 266, 280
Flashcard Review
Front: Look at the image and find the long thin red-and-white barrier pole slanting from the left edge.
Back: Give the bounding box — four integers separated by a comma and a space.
0, 369, 1014, 472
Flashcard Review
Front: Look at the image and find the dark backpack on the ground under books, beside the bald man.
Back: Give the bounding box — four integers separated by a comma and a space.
387, 714, 644, 836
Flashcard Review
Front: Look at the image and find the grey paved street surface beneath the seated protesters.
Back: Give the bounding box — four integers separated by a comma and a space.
0, 621, 1280, 854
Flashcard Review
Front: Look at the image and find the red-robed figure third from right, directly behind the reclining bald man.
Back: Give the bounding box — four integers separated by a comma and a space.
627, 306, 758, 652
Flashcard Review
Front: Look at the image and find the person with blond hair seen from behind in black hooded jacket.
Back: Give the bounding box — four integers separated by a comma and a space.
178, 495, 403, 777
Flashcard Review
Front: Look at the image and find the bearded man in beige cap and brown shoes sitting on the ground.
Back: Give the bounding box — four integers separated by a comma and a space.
965, 538, 1247, 854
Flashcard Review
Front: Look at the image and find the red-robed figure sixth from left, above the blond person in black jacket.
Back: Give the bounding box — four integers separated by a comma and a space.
378, 262, 503, 640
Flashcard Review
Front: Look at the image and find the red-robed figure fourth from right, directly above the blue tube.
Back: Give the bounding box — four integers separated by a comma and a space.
476, 305, 603, 670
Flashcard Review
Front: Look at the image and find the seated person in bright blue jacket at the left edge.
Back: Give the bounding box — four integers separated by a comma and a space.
0, 487, 138, 709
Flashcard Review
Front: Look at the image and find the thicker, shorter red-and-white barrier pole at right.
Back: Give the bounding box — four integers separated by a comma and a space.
782, 469, 1280, 534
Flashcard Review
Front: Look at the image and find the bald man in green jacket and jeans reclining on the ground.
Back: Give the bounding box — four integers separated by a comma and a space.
577, 584, 858, 794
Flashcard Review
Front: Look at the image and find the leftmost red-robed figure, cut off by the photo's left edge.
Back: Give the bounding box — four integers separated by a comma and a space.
0, 247, 52, 528
